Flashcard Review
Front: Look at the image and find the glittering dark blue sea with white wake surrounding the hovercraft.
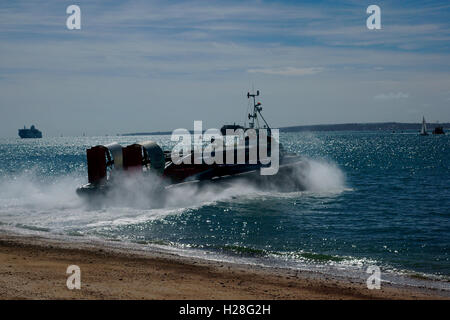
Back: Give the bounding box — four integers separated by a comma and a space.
0, 132, 450, 290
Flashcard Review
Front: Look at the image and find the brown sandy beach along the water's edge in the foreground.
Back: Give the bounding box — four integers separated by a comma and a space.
0, 233, 449, 300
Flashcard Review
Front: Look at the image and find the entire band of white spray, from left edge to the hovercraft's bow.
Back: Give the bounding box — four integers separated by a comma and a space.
0, 159, 345, 235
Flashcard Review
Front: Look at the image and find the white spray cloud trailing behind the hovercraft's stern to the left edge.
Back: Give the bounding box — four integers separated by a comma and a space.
0, 170, 97, 231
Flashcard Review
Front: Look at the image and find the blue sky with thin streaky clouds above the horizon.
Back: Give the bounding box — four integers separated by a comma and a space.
0, 0, 450, 137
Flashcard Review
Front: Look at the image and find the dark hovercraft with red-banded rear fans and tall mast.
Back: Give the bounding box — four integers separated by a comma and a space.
77, 91, 303, 197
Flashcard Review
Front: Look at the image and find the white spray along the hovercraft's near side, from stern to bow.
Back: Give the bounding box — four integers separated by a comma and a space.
82, 158, 345, 209
